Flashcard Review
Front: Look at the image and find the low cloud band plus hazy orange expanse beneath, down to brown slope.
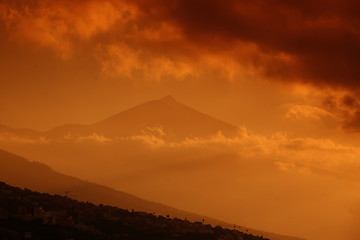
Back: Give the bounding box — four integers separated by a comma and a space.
0, 127, 360, 240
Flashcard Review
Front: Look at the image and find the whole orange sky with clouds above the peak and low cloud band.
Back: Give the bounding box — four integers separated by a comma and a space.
0, 0, 360, 136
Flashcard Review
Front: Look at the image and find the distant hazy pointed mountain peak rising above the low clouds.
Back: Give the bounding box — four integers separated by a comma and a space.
48, 96, 237, 140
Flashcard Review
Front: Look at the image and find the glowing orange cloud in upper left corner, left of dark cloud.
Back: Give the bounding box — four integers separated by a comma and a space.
0, 0, 135, 59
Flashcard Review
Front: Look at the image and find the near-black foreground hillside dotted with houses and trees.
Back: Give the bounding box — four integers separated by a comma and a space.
0, 182, 266, 240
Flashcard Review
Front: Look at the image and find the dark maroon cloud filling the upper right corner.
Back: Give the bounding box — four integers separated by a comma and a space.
131, 0, 360, 88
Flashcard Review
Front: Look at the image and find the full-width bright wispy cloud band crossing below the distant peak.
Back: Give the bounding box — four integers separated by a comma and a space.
0, 127, 360, 182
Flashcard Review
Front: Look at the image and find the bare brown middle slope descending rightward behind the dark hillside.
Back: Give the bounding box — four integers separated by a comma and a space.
0, 150, 301, 240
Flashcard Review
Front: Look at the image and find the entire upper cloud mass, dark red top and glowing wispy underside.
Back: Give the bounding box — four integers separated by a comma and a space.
0, 0, 360, 132
